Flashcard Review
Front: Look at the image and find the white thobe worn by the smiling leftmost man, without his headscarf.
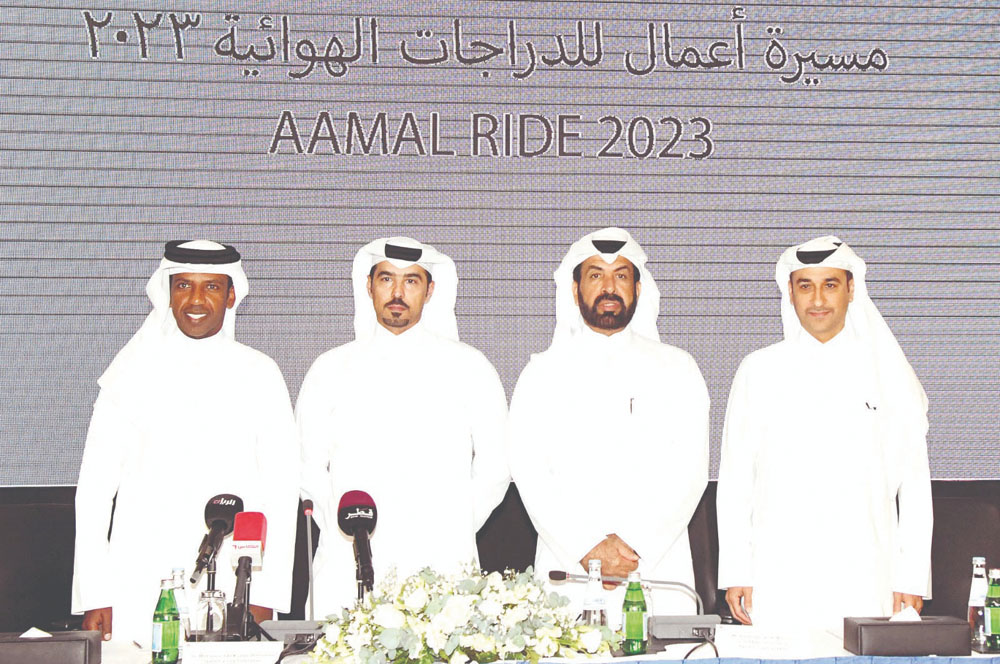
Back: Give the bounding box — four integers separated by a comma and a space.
72, 333, 298, 646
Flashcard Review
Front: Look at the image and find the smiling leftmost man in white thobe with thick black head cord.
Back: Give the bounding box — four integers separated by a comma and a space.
72, 240, 297, 645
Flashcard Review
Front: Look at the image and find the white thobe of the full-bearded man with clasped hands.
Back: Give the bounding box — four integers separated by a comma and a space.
509, 328, 709, 623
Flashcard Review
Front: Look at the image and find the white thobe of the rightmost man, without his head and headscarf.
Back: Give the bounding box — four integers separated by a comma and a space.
718, 333, 932, 629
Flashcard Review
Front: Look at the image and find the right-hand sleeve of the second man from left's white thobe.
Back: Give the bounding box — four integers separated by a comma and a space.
468, 356, 510, 530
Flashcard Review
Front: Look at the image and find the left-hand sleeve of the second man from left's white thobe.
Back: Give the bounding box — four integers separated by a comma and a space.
295, 360, 336, 533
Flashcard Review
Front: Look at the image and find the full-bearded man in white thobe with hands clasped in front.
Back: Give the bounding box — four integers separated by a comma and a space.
508, 228, 709, 622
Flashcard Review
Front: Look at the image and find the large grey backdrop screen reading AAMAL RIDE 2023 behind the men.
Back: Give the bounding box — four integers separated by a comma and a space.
0, 0, 1000, 485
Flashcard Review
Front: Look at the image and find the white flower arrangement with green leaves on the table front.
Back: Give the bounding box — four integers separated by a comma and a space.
312, 565, 621, 664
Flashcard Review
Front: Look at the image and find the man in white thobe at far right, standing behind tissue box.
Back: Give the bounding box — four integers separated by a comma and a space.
718, 236, 932, 630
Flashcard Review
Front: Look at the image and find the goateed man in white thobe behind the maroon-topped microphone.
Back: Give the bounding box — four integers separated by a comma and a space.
296, 237, 510, 616
